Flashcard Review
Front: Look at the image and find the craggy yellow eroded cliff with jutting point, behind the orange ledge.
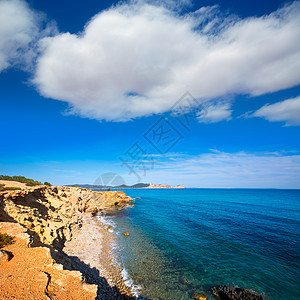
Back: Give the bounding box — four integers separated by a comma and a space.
0, 186, 133, 249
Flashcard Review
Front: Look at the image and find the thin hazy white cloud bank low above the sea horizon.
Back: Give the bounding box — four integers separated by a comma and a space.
142, 150, 300, 188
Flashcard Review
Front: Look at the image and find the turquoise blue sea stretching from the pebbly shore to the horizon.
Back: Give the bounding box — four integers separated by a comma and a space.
102, 189, 300, 300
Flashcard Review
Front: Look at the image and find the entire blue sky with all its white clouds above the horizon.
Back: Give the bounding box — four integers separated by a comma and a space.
0, 0, 300, 188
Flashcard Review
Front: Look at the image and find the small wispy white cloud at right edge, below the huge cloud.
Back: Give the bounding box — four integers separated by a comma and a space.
252, 96, 300, 126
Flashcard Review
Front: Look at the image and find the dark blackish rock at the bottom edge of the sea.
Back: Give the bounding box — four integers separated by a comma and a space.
211, 285, 265, 300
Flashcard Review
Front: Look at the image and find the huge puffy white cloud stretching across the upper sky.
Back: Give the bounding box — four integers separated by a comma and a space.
33, 2, 300, 122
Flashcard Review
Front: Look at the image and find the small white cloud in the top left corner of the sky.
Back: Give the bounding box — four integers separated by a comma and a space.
0, 0, 55, 72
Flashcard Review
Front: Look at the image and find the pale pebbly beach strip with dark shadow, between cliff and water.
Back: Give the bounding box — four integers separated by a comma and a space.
63, 214, 135, 300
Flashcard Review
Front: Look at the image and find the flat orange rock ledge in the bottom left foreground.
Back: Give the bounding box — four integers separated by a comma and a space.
0, 222, 97, 300
